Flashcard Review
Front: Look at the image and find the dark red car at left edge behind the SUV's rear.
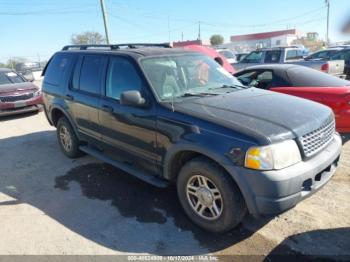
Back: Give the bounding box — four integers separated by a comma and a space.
0, 68, 43, 116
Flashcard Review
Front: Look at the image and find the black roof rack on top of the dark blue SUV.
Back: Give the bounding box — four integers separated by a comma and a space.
62, 43, 171, 50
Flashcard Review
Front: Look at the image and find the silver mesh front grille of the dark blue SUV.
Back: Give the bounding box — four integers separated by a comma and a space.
299, 118, 335, 157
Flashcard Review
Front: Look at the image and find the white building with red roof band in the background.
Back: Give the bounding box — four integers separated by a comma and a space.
225, 29, 299, 52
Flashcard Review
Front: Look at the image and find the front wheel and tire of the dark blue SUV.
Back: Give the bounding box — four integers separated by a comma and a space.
177, 157, 247, 233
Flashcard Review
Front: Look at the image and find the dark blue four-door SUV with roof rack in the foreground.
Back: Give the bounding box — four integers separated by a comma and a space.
43, 44, 341, 232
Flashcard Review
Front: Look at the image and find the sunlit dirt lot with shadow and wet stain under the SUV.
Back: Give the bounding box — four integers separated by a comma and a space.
0, 110, 350, 258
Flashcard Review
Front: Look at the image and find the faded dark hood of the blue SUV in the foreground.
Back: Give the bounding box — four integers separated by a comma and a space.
175, 88, 333, 144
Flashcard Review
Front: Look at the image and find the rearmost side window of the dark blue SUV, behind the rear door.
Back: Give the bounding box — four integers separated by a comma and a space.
44, 54, 74, 86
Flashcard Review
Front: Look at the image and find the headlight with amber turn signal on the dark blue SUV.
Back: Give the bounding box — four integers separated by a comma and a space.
245, 140, 301, 170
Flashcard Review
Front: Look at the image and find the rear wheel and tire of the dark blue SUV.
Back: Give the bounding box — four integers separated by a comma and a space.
57, 117, 82, 158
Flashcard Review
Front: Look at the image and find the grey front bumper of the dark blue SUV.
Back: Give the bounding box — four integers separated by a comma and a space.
226, 134, 342, 217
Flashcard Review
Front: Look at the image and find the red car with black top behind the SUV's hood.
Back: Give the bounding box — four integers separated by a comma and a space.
235, 64, 350, 133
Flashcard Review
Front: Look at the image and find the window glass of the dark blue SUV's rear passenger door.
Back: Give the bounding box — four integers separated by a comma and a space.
79, 55, 106, 94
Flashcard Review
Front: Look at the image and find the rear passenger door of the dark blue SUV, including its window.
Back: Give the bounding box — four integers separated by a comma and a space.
66, 54, 107, 141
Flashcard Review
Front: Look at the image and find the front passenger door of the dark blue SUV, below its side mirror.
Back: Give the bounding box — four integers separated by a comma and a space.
100, 55, 159, 173
